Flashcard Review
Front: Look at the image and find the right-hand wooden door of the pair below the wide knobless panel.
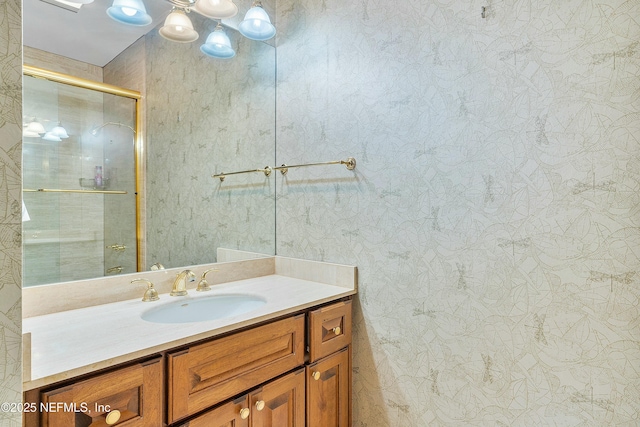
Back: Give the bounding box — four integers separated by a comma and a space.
249, 368, 305, 427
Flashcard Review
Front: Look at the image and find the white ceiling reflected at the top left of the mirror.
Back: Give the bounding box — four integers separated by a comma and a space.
22, 0, 171, 67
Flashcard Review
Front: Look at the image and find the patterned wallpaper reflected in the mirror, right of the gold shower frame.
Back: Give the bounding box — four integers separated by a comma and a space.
145, 14, 275, 267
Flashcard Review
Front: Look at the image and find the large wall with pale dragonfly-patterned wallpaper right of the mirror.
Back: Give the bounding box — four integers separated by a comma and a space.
276, 0, 640, 427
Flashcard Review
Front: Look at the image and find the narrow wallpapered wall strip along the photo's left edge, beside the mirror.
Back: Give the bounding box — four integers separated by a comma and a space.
0, 0, 22, 427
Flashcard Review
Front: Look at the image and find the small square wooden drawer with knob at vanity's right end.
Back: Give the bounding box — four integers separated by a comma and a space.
309, 300, 351, 362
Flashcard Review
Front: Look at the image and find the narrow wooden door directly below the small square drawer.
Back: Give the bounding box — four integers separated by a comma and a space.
307, 347, 351, 427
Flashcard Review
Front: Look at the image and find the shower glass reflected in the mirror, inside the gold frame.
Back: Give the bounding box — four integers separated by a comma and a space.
22, 70, 138, 286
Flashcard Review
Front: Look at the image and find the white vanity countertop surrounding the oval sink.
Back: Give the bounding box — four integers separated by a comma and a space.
22, 274, 356, 391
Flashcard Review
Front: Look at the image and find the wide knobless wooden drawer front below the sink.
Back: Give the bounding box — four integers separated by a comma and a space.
167, 315, 304, 423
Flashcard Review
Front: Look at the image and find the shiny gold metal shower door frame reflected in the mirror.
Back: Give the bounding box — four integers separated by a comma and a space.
22, 64, 145, 271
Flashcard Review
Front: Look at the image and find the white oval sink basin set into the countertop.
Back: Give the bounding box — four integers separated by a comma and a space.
141, 294, 267, 323
